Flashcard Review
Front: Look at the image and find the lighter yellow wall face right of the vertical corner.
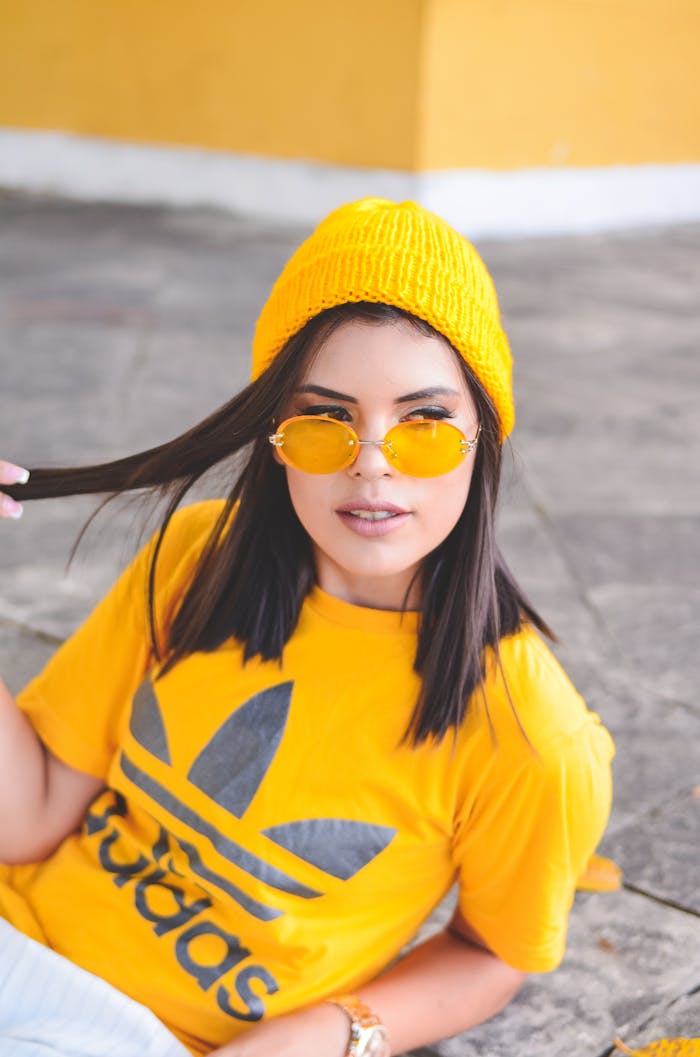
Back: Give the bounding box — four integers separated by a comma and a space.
417, 0, 700, 169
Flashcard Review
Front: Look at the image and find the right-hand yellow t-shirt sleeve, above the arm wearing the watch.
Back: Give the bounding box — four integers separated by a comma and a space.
455, 712, 613, 972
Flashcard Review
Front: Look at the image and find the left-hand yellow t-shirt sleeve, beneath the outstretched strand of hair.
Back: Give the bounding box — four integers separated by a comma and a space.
17, 503, 218, 778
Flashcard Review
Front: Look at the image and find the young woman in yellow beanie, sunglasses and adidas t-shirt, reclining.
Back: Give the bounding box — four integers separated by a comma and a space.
0, 199, 612, 1057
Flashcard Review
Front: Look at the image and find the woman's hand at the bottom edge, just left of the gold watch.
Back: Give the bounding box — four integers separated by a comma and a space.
209, 1002, 350, 1057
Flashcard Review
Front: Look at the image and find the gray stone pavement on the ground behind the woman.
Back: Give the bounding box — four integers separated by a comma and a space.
0, 193, 700, 1057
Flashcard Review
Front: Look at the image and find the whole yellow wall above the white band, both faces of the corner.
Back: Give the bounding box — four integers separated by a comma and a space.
0, 0, 700, 171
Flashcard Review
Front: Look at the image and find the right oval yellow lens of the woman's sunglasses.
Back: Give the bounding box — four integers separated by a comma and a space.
384, 421, 464, 477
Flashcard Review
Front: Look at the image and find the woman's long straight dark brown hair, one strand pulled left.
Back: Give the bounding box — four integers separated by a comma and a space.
3, 302, 554, 745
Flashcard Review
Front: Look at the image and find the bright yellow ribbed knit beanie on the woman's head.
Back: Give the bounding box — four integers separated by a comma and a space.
253, 198, 515, 440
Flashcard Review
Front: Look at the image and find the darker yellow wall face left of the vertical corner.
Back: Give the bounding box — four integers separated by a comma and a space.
0, 0, 423, 169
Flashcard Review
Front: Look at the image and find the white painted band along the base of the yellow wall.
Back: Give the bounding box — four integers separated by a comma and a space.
0, 128, 700, 238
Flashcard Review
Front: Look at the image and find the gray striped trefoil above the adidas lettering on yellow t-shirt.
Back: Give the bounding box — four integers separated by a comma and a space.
122, 680, 397, 921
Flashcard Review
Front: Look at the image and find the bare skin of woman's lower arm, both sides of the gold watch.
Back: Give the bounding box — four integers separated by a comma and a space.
211, 917, 526, 1057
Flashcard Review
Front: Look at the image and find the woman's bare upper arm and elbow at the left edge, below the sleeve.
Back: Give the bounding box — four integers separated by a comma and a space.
0, 679, 104, 864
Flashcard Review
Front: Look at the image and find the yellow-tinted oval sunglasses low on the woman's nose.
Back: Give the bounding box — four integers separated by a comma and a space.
268, 414, 481, 477
